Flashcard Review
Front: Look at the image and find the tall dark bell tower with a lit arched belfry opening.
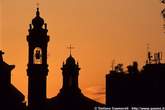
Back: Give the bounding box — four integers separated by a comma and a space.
27, 7, 49, 110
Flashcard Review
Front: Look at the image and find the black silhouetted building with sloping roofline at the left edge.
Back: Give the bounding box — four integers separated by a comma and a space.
0, 51, 26, 110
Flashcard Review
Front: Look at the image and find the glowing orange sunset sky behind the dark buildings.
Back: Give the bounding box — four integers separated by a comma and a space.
0, 0, 165, 103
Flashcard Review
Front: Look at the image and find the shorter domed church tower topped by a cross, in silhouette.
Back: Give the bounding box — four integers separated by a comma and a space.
60, 50, 81, 95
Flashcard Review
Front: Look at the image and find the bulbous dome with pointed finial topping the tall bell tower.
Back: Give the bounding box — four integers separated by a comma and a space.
32, 8, 44, 27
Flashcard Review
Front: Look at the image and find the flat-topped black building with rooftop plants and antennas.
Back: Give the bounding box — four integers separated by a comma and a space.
106, 54, 165, 107
